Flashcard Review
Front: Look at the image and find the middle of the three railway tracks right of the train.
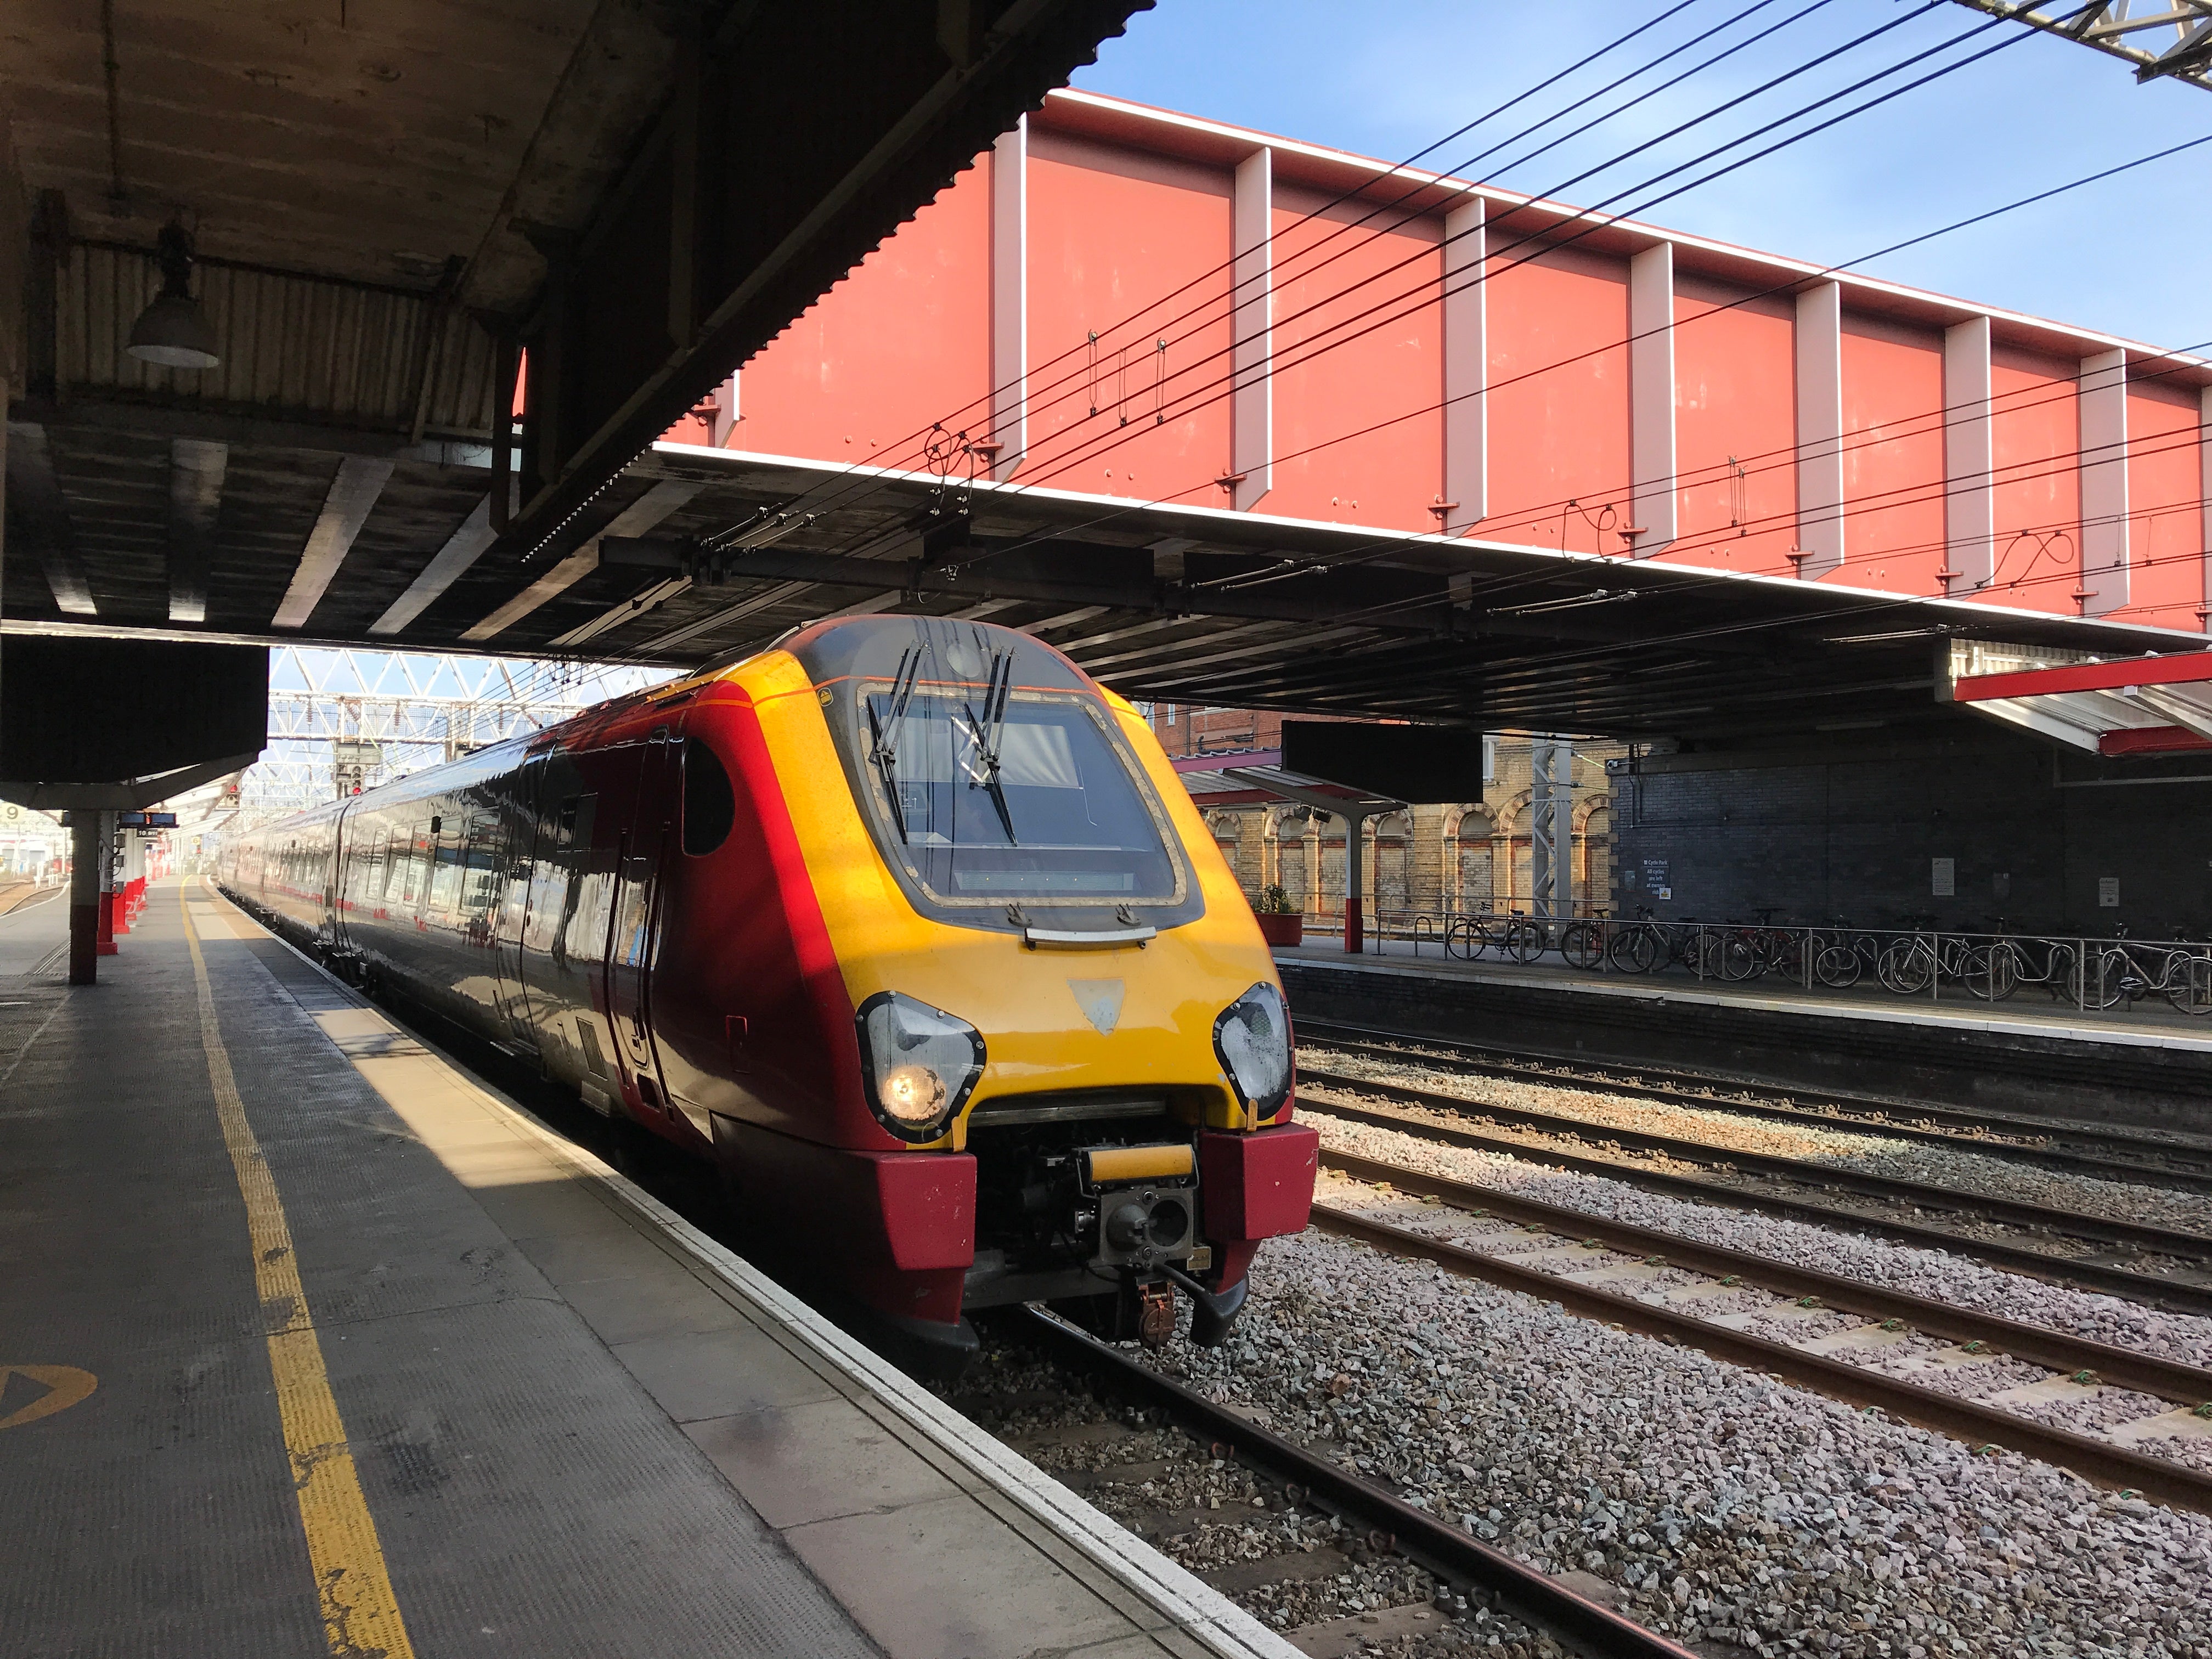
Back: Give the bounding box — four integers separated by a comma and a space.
1299, 1066, 2212, 1314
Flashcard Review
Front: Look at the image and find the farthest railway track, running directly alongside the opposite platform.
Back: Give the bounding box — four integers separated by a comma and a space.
1299, 1020, 2212, 1192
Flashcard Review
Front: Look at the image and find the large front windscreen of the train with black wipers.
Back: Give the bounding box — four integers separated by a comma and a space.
858, 686, 1181, 905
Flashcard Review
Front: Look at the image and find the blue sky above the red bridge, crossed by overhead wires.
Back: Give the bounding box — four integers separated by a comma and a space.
1075, 0, 2212, 347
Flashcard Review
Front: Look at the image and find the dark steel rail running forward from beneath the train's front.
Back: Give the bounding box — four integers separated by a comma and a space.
1026, 1307, 1690, 1659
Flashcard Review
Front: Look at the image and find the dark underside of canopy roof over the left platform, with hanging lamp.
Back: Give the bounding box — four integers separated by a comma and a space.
0, 0, 1146, 646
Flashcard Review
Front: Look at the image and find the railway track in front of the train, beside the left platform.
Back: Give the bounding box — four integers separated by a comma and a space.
949, 1310, 1690, 1659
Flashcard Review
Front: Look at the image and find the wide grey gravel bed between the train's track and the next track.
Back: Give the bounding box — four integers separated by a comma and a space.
1153, 1212, 2212, 1659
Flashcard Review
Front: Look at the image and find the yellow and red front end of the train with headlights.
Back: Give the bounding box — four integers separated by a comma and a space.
676, 617, 1316, 1358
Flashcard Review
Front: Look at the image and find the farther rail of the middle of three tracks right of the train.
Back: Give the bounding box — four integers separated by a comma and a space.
1299, 1070, 2212, 1261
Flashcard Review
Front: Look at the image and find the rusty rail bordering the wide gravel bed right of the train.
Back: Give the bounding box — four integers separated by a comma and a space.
1314, 1203, 2212, 1513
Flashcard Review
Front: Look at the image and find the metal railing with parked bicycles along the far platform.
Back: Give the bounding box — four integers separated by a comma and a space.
1345, 911, 2212, 1015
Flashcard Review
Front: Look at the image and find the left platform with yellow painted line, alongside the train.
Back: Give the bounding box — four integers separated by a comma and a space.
0, 883, 1292, 1659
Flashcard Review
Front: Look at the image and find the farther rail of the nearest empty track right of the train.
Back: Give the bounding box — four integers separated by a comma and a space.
1321, 1148, 2212, 1404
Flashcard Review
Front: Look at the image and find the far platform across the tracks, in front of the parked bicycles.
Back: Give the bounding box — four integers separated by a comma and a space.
1274, 940, 2212, 1132
